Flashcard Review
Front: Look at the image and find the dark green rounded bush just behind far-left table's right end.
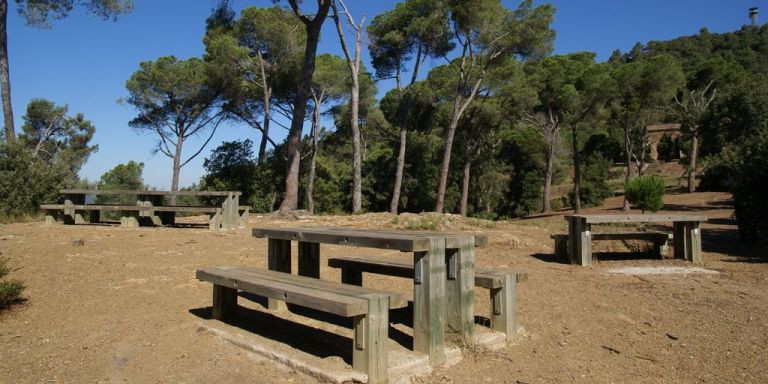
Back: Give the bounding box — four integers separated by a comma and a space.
200, 139, 256, 204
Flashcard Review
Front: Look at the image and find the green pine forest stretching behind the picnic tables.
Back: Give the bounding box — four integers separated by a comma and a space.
0, 0, 768, 238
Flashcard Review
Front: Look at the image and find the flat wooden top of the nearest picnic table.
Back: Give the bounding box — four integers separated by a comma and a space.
252, 227, 488, 252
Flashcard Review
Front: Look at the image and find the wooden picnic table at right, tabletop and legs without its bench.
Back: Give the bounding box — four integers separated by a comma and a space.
565, 214, 707, 266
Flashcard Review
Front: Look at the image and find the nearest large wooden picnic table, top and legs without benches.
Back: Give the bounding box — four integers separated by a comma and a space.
253, 227, 487, 366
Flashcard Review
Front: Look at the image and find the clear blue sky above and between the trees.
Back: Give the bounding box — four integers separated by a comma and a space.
8, 0, 768, 189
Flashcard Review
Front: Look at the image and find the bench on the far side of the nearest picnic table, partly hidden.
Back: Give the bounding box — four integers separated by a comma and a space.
328, 256, 528, 340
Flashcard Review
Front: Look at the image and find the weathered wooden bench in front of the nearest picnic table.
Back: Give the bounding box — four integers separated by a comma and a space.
196, 267, 408, 383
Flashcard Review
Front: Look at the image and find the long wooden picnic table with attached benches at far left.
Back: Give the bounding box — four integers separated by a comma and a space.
40, 189, 250, 229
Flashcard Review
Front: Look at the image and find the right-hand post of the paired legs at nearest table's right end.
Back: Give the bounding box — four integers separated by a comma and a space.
445, 236, 475, 345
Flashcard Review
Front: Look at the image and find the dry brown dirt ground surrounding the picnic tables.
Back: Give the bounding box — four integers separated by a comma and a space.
0, 193, 768, 383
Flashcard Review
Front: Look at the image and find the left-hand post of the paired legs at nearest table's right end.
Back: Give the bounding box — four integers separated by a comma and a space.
413, 237, 446, 366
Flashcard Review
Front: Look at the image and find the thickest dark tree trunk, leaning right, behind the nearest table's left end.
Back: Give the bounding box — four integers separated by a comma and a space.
280, 10, 330, 212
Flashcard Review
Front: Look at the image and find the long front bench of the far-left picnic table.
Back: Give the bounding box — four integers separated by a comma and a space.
40, 202, 251, 229
